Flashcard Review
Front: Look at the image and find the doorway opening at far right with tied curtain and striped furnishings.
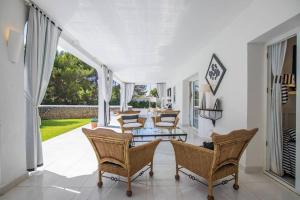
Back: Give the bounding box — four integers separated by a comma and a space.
266, 36, 299, 188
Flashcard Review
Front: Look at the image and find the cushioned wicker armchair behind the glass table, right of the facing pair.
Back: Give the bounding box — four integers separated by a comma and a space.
152, 110, 180, 132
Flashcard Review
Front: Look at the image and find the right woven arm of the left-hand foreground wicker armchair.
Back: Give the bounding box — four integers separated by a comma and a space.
129, 139, 161, 175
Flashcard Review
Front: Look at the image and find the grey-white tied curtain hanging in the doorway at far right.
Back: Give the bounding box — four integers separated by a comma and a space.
268, 41, 287, 176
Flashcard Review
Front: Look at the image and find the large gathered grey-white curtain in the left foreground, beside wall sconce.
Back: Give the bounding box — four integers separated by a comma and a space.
24, 7, 61, 171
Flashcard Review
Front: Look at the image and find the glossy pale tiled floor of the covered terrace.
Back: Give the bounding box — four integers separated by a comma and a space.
0, 114, 300, 200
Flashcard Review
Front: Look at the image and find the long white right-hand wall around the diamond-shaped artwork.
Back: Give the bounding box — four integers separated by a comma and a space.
173, 0, 300, 167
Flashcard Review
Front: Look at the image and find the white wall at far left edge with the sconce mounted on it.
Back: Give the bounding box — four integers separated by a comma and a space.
0, 0, 27, 192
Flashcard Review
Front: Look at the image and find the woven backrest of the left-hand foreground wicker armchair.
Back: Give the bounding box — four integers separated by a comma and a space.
82, 128, 132, 168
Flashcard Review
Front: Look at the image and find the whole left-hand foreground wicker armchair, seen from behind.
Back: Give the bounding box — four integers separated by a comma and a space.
82, 128, 160, 196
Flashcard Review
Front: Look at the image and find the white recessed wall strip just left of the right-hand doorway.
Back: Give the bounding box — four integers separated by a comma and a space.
244, 43, 267, 172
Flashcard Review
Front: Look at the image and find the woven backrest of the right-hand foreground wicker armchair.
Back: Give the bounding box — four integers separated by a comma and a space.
211, 128, 258, 171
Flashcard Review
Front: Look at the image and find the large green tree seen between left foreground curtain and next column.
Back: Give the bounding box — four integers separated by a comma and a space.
42, 52, 98, 105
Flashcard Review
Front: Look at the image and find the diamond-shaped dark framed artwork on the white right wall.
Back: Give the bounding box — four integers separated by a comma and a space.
205, 54, 226, 95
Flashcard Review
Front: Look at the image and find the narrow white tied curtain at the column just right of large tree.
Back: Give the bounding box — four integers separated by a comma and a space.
101, 65, 113, 125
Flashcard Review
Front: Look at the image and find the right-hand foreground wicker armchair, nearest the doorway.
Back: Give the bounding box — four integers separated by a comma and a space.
171, 129, 258, 200
